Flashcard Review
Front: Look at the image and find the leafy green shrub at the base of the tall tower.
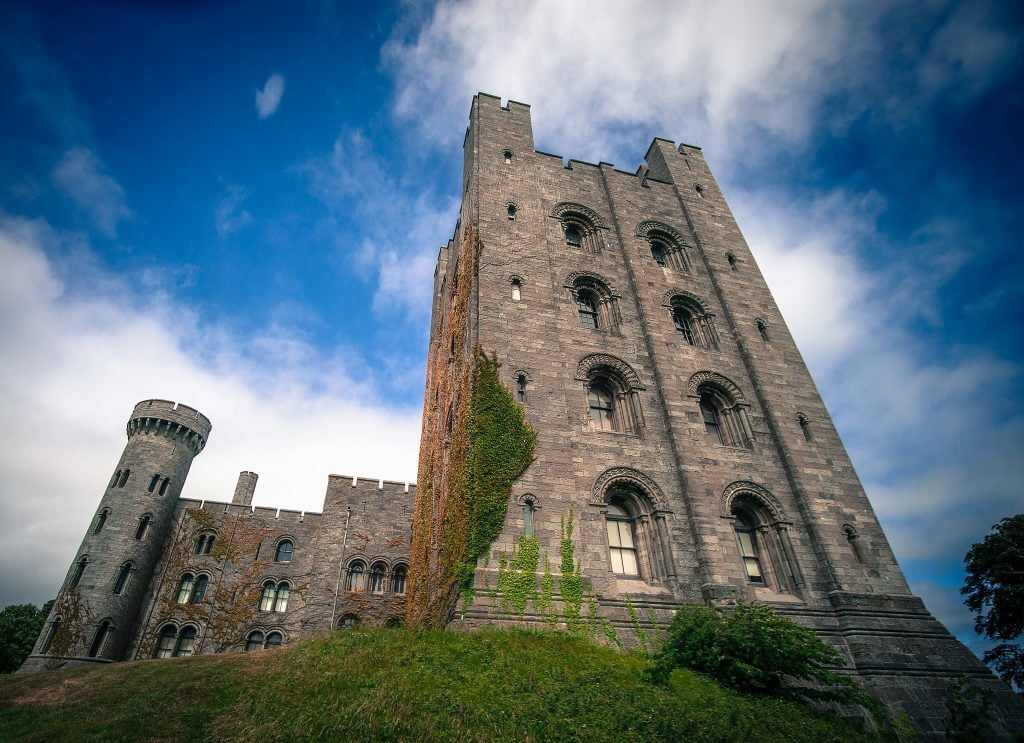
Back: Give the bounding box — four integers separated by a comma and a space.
654, 605, 876, 708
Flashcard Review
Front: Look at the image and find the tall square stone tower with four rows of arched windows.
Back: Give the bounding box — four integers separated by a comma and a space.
411, 94, 1022, 733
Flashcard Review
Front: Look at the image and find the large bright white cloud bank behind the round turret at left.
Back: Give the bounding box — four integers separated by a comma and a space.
0, 219, 420, 604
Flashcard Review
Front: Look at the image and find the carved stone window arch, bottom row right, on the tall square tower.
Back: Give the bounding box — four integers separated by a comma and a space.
722, 481, 804, 594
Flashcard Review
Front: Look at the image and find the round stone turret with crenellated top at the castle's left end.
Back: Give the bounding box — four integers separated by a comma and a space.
20, 400, 211, 671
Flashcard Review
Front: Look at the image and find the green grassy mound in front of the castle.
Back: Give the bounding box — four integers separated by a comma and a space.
0, 629, 877, 743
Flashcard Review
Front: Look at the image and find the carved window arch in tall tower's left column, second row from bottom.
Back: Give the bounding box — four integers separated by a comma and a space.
575, 353, 644, 436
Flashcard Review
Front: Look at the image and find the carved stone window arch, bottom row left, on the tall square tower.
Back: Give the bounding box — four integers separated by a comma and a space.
593, 467, 676, 585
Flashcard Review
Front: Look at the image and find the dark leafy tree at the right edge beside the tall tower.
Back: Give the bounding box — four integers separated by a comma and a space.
961, 514, 1024, 689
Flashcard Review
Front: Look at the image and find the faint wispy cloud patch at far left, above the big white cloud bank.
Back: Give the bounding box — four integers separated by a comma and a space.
51, 146, 132, 237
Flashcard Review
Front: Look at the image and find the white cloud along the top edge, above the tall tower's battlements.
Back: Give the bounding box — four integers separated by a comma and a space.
384, 0, 1020, 171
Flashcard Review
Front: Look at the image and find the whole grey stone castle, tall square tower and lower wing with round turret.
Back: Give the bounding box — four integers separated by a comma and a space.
23, 94, 1024, 736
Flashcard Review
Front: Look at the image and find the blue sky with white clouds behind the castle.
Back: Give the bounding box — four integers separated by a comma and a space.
0, 0, 1024, 663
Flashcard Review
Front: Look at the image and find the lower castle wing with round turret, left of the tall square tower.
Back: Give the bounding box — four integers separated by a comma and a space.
20, 400, 416, 672
